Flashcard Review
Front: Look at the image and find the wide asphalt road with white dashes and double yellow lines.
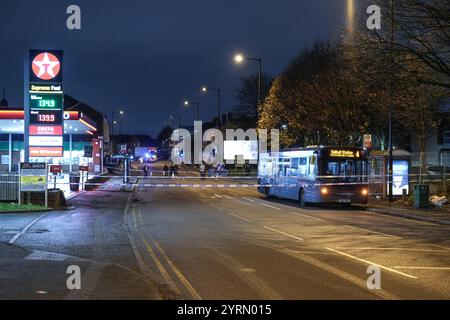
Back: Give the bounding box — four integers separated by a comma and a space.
0, 164, 450, 299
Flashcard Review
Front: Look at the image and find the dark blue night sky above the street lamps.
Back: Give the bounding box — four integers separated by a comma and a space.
0, 0, 346, 136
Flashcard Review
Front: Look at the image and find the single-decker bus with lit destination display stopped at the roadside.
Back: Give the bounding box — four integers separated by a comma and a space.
258, 147, 369, 207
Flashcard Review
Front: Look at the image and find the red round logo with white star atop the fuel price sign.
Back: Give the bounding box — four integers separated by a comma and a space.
30, 50, 63, 83
